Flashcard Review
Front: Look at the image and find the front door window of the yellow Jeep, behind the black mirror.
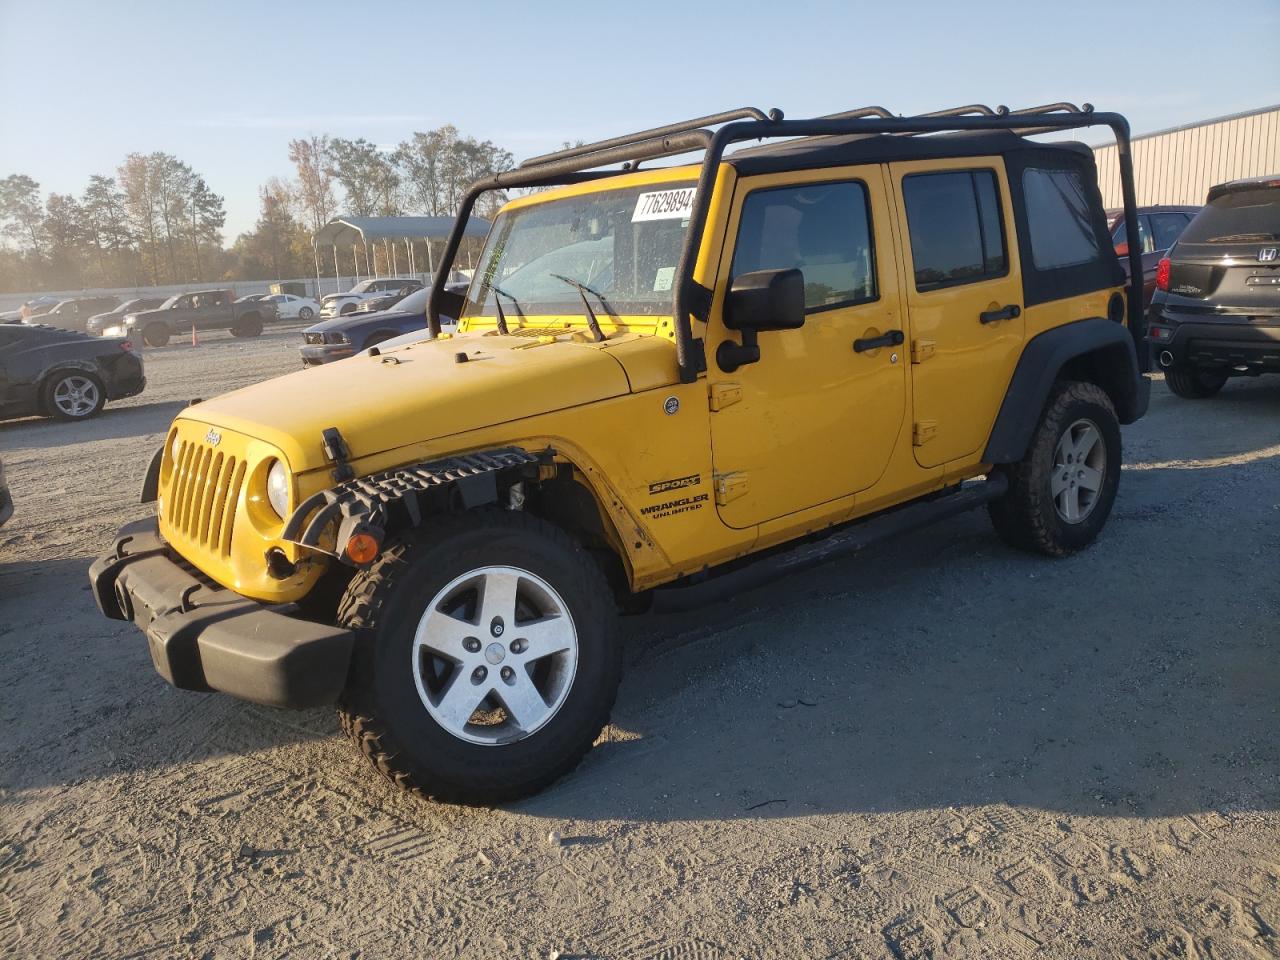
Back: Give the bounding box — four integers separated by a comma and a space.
731, 180, 879, 312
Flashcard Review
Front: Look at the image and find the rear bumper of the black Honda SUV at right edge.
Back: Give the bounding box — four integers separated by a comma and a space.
1147, 316, 1280, 374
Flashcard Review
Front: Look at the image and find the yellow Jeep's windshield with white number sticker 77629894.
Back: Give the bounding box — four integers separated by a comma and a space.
462, 183, 694, 324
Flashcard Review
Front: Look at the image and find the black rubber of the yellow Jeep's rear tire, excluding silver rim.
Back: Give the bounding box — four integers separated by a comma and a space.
987, 380, 1121, 557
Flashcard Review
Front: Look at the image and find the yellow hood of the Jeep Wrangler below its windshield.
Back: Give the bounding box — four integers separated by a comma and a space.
182, 335, 676, 472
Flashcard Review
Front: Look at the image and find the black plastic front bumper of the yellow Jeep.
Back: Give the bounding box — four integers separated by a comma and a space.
88, 520, 352, 708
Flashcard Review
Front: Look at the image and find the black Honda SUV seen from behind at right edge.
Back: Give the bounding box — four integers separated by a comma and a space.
1147, 175, 1280, 399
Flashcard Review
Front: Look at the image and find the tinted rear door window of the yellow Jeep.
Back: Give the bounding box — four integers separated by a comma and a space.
902, 170, 1009, 293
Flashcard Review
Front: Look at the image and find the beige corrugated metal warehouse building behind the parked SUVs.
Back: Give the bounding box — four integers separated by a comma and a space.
1093, 104, 1280, 207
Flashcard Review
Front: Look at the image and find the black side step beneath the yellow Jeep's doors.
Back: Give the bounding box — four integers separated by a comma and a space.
652, 474, 1009, 613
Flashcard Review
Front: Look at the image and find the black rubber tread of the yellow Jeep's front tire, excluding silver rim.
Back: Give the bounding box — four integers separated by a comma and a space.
338, 509, 622, 805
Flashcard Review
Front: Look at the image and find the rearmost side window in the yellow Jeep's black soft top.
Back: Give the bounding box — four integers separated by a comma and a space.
1023, 168, 1100, 270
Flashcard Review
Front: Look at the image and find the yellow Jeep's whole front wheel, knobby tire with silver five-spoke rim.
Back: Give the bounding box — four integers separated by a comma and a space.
339, 509, 622, 805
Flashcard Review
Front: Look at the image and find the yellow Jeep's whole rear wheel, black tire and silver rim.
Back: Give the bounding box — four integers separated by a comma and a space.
987, 381, 1121, 557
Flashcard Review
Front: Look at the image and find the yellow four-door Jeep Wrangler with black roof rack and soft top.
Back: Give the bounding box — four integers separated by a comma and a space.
91, 104, 1149, 803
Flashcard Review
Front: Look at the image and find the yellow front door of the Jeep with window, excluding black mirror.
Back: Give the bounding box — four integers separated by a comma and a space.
707, 165, 908, 529
